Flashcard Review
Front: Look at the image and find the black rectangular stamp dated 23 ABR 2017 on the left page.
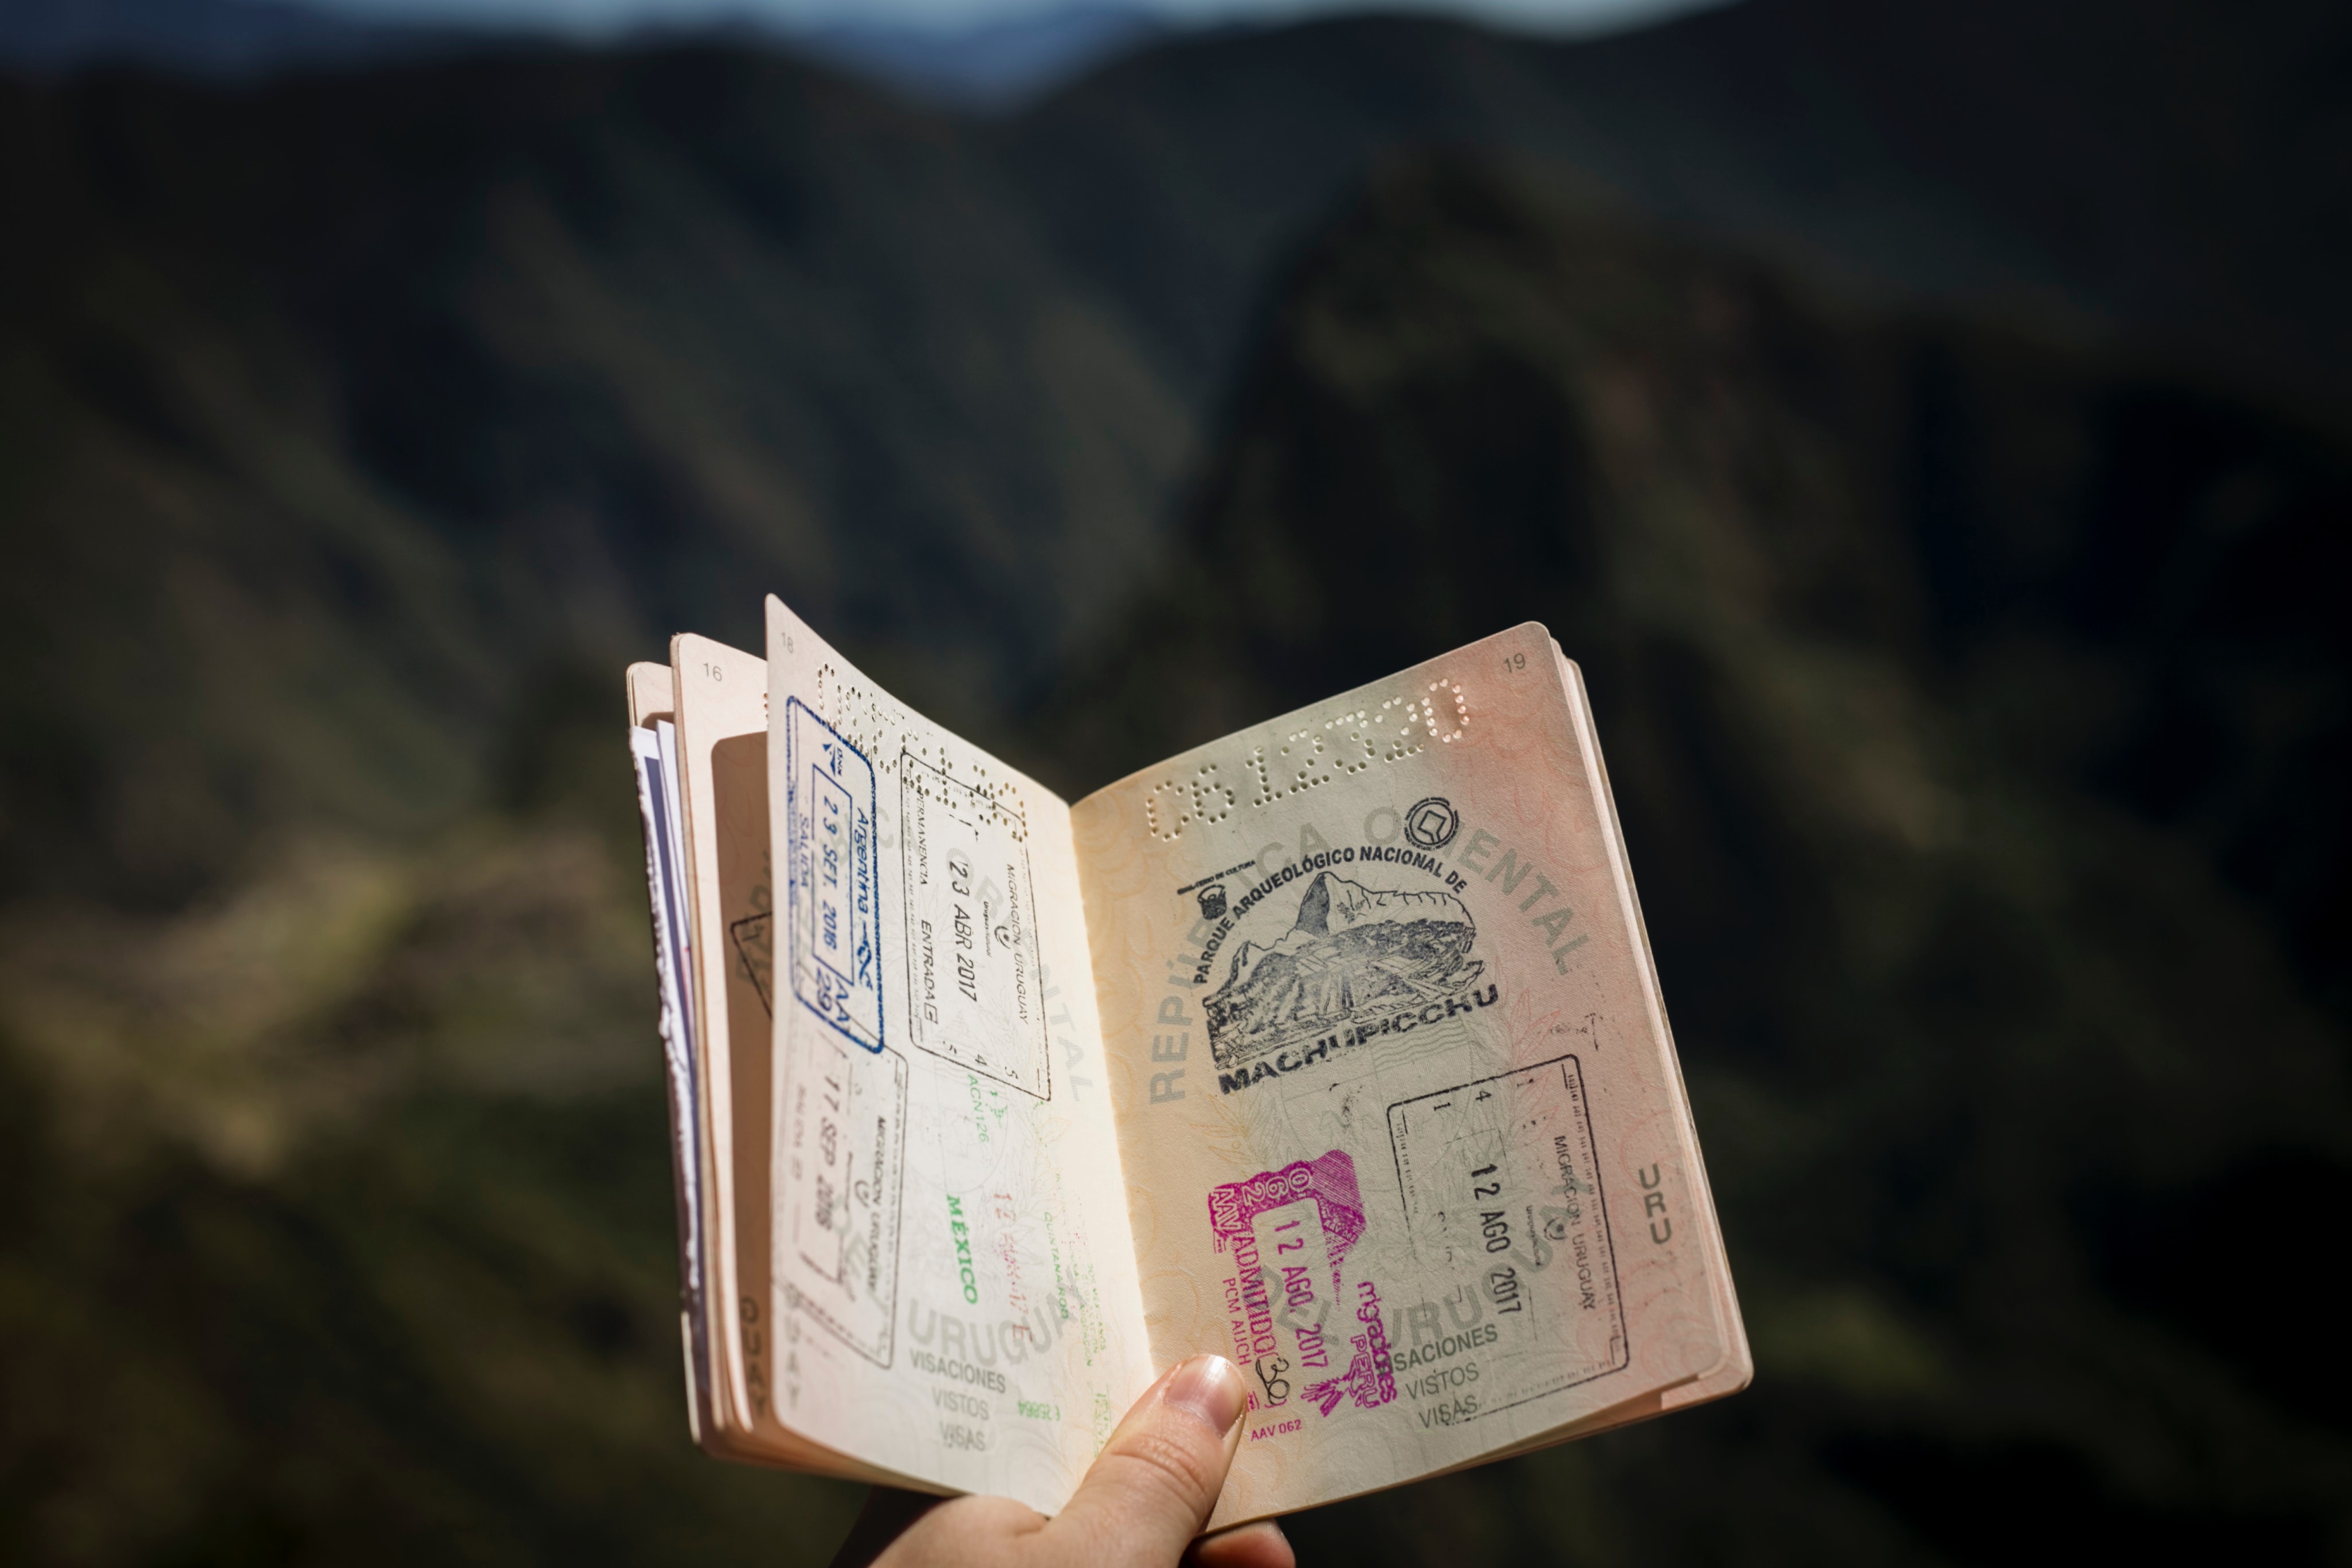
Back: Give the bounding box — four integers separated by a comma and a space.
899, 752, 1054, 1100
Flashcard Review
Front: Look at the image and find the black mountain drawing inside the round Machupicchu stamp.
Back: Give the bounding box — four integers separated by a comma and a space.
1204, 872, 1484, 1067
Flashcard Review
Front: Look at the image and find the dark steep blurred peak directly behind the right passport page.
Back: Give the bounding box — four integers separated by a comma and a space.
1044, 158, 2352, 1563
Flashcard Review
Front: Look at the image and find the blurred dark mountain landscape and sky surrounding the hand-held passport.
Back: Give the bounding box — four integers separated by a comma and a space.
0, 0, 2352, 1568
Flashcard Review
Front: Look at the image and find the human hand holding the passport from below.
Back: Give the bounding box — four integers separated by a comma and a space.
833, 1357, 1296, 1568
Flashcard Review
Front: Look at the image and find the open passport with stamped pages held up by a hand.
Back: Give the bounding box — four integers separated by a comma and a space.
628, 597, 1750, 1528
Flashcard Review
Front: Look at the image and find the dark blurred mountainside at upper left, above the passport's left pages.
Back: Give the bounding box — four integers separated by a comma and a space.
0, 54, 1190, 896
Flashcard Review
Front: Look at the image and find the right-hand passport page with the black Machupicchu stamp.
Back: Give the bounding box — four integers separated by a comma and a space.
1072, 625, 1745, 1526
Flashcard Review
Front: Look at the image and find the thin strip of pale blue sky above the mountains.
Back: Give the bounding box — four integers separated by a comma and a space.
311, 0, 1710, 38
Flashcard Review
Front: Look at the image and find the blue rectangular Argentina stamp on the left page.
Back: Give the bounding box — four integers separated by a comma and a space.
783, 696, 882, 1051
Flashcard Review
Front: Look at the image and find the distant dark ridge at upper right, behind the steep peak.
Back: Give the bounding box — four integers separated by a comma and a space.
1016, 0, 2352, 411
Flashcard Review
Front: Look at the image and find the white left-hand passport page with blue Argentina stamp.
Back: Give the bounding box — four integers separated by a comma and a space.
762, 597, 1153, 1512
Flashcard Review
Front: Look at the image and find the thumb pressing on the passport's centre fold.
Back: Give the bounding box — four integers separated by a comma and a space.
1044, 1357, 1249, 1563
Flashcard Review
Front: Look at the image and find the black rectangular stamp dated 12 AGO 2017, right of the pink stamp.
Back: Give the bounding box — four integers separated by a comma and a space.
1387, 1056, 1630, 1425
